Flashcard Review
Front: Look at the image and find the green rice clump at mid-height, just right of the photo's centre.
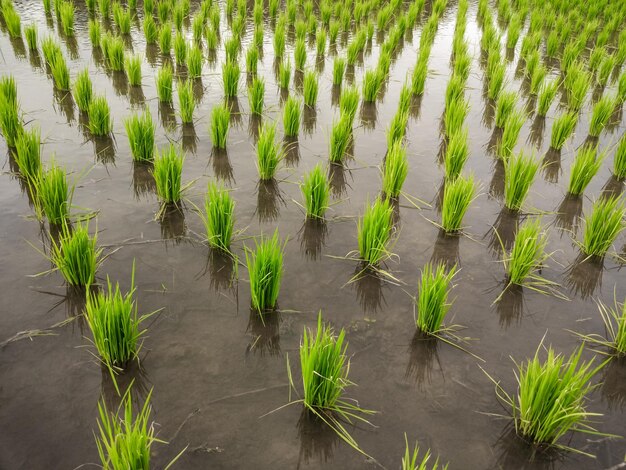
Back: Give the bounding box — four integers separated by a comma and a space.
357, 199, 393, 266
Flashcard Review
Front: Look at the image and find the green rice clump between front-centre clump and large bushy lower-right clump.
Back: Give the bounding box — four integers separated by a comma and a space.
415, 263, 457, 335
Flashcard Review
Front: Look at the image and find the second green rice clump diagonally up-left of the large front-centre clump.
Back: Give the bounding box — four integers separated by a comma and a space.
202, 181, 235, 251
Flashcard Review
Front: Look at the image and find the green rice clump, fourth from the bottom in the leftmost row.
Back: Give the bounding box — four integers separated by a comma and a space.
33, 161, 73, 225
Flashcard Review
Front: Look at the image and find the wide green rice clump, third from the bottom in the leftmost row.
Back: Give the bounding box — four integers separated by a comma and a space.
50, 223, 102, 287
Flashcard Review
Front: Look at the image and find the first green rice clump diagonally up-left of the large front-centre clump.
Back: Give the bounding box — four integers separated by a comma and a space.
246, 230, 284, 312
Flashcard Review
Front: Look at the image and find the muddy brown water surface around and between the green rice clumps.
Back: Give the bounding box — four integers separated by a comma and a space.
0, 2, 626, 469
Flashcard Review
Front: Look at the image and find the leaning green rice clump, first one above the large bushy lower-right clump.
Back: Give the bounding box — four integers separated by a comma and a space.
504, 219, 547, 285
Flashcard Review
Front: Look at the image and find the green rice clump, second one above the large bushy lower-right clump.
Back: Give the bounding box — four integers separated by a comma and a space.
504, 152, 539, 211
